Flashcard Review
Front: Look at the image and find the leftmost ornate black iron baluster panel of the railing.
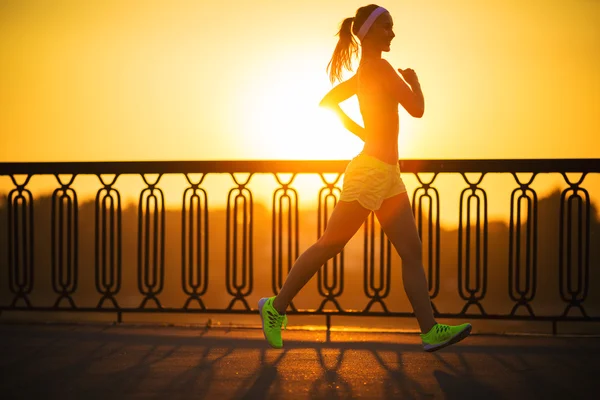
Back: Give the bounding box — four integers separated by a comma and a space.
7, 175, 34, 307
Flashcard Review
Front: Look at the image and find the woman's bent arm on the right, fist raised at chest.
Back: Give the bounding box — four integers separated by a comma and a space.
377, 59, 425, 118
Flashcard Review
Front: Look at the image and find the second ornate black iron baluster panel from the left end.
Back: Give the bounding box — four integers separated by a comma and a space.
50, 174, 79, 308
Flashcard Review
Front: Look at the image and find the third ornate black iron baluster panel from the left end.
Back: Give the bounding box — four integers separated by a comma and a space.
94, 174, 122, 308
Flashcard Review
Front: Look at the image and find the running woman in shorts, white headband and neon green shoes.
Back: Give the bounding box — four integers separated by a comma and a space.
258, 4, 471, 351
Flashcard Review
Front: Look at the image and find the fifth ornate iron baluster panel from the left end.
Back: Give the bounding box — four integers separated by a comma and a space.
181, 174, 209, 310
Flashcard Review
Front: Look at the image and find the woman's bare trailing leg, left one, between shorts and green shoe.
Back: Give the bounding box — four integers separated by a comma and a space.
273, 201, 371, 314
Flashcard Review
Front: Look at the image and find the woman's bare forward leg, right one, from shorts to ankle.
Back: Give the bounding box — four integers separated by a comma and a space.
375, 192, 436, 333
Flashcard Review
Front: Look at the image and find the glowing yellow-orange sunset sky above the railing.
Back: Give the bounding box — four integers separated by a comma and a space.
0, 0, 600, 161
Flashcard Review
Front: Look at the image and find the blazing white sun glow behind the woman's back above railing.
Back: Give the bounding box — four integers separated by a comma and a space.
244, 61, 362, 160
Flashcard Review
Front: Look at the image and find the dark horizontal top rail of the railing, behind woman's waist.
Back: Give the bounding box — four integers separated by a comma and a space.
0, 158, 600, 175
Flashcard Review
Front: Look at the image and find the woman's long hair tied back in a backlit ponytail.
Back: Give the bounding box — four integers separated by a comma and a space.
327, 4, 379, 84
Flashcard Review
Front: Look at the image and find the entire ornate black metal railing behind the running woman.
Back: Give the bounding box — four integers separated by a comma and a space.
0, 159, 600, 332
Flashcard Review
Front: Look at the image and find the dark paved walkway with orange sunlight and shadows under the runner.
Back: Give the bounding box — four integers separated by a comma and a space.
0, 324, 600, 400
